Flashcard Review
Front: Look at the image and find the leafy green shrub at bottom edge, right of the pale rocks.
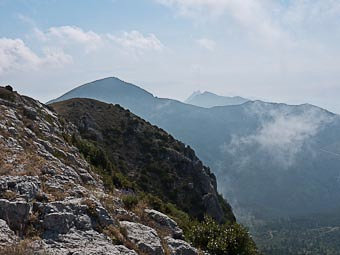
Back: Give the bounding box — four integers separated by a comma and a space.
186, 216, 259, 255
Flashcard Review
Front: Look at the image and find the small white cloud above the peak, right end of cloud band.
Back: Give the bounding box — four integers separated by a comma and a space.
107, 30, 164, 51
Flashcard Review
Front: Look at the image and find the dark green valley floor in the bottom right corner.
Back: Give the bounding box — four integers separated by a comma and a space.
250, 211, 340, 255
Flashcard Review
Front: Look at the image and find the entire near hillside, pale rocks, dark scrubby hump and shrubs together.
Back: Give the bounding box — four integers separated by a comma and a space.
0, 87, 257, 255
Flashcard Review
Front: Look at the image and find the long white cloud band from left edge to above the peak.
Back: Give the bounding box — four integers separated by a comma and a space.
0, 25, 164, 75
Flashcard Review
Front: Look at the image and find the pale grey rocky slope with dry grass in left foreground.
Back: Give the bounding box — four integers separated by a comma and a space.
0, 87, 202, 255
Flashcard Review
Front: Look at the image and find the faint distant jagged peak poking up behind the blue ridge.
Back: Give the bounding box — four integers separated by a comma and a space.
184, 91, 250, 108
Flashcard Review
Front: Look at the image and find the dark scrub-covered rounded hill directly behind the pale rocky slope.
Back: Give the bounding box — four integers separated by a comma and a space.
51, 99, 235, 223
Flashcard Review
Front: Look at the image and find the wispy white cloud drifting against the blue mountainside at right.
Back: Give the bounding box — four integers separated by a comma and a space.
223, 103, 334, 168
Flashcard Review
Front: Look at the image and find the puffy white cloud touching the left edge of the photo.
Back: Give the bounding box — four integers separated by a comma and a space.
0, 38, 72, 74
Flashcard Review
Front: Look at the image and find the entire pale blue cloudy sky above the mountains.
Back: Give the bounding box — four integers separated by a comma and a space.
0, 0, 340, 113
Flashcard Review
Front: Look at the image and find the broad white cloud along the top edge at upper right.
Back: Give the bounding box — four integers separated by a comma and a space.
154, 0, 340, 47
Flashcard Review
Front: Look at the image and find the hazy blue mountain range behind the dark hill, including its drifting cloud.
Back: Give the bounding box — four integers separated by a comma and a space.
50, 78, 340, 222
